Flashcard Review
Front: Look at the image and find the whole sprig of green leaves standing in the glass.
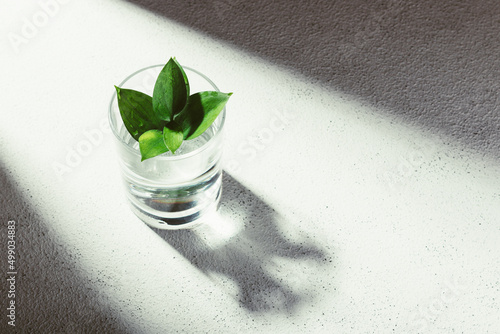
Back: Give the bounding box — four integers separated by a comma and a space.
115, 58, 233, 161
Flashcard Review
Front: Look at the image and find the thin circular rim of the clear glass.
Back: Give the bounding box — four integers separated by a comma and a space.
108, 64, 226, 160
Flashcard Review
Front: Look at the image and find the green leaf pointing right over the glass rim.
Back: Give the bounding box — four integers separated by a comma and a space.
175, 92, 233, 140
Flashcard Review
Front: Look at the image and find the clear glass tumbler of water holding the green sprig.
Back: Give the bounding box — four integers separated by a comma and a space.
109, 65, 226, 229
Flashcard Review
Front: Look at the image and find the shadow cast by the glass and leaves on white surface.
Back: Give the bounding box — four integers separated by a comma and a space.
154, 173, 331, 313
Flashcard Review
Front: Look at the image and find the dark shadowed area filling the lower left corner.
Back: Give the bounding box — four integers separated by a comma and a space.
0, 162, 131, 334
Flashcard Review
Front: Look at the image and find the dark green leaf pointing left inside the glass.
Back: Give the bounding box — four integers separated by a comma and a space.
115, 86, 165, 140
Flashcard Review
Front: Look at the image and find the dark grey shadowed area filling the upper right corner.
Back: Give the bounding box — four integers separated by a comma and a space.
123, 0, 500, 158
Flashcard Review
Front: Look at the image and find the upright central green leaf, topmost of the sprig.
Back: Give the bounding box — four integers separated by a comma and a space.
153, 58, 189, 121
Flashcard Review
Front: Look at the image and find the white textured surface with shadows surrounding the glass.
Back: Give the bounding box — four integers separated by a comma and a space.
0, 0, 500, 333
